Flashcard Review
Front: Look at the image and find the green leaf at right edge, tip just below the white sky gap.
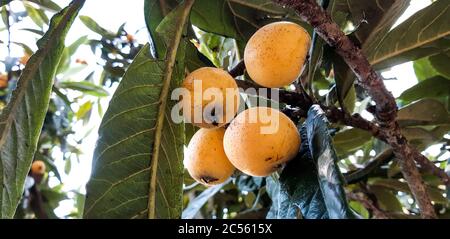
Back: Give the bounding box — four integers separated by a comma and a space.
398, 76, 450, 103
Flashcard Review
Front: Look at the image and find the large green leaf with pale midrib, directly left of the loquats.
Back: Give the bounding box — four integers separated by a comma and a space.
84, 0, 193, 218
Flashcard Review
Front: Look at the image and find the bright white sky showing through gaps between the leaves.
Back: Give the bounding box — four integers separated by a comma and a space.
0, 0, 431, 217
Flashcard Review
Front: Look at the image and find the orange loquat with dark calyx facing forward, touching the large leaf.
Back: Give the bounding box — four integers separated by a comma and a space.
182, 67, 239, 128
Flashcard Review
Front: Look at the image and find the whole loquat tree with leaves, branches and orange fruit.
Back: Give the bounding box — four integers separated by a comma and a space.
0, 0, 450, 219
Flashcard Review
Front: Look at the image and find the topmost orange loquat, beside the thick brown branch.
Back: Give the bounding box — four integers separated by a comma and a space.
244, 22, 311, 88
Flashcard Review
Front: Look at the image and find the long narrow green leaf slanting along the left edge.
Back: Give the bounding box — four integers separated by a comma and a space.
0, 0, 85, 218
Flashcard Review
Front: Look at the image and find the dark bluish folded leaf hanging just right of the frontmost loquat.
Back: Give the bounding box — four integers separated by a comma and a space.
266, 105, 355, 219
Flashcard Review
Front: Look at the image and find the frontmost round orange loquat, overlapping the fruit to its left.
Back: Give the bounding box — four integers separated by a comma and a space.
223, 107, 300, 177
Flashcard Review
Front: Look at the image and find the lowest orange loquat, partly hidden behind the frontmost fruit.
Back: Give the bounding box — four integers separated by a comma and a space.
184, 128, 235, 186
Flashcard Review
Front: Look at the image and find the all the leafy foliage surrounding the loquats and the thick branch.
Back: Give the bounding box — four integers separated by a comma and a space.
0, 0, 450, 218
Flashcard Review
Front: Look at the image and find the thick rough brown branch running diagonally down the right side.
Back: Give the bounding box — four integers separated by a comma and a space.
273, 0, 436, 218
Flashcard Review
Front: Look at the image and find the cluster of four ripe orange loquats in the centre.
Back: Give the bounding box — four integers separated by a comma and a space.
183, 22, 311, 186
